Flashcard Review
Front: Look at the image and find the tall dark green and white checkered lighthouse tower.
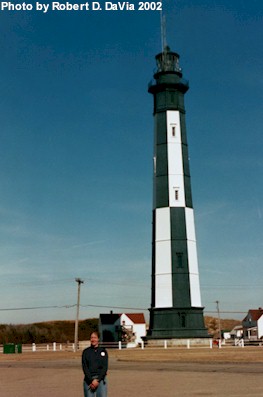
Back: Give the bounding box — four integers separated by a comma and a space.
147, 46, 208, 339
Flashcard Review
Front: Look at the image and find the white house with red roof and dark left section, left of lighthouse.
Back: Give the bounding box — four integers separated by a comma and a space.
99, 312, 146, 347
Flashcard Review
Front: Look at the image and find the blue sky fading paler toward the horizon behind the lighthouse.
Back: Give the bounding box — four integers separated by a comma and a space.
0, 0, 263, 323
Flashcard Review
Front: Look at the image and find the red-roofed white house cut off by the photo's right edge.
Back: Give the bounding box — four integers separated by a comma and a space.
242, 307, 263, 340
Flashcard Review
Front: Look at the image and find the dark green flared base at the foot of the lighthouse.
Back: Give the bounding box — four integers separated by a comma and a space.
146, 307, 209, 340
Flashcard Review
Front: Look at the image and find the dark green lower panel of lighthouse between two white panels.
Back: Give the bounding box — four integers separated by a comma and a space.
170, 207, 191, 307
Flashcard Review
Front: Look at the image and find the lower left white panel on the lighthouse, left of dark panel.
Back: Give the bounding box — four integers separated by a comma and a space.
155, 208, 173, 307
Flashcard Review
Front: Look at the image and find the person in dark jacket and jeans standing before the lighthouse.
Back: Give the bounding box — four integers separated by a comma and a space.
82, 331, 108, 397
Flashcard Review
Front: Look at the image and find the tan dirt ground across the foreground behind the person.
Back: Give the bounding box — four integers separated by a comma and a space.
0, 347, 263, 397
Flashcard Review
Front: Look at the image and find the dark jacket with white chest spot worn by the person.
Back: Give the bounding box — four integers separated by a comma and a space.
82, 346, 108, 385
